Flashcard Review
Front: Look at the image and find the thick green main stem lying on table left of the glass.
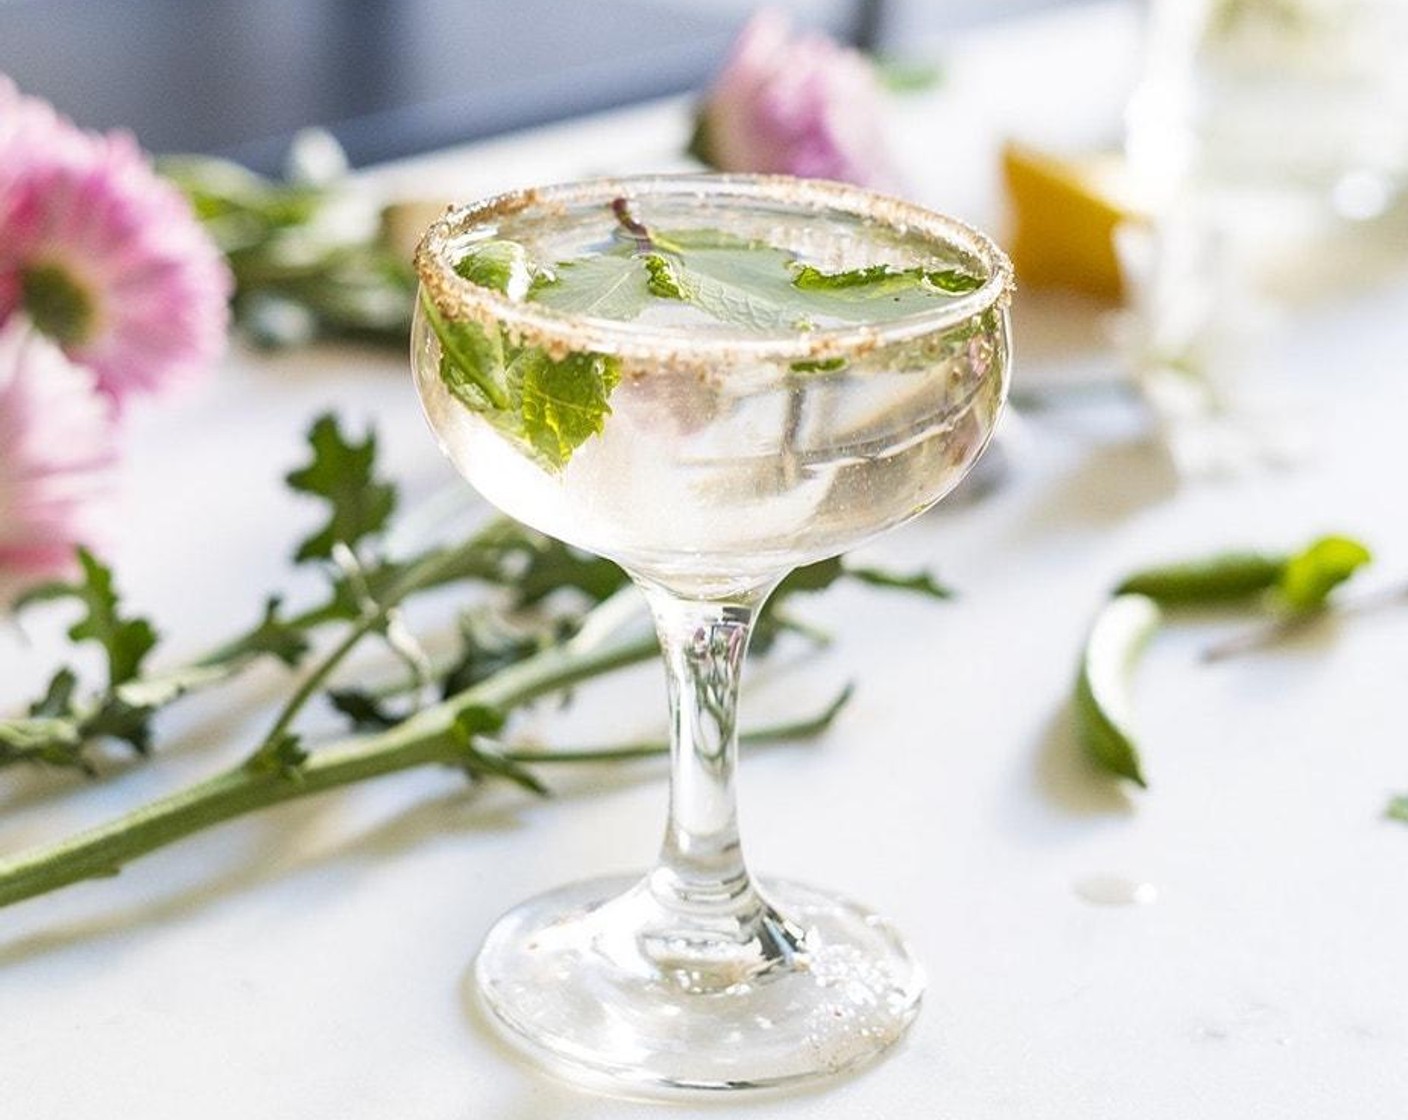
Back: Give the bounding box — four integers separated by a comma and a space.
0, 625, 656, 906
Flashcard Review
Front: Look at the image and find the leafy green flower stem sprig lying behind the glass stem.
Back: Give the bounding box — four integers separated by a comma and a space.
0, 417, 946, 906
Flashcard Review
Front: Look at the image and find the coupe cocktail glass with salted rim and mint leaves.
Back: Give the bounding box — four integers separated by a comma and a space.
413, 176, 1011, 1090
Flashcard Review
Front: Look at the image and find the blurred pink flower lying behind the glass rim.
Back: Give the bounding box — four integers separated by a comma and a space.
690, 10, 895, 187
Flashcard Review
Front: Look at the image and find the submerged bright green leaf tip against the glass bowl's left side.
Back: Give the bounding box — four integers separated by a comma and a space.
508, 348, 621, 469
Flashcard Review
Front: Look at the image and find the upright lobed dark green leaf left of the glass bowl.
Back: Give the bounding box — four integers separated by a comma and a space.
287, 414, 396, 564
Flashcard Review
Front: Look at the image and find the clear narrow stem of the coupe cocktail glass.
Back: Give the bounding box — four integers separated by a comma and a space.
645, 582, 776, 941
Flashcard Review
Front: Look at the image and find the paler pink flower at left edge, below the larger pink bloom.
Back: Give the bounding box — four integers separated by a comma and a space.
0, 316, 117, 578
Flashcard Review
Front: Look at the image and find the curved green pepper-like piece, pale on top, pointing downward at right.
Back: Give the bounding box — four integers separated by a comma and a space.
1073, 595, 1160, 786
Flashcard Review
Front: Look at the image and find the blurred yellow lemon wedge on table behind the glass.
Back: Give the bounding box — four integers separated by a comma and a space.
1002, 142, 1145, 301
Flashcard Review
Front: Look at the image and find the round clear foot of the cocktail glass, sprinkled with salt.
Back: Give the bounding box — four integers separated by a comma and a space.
474, 872, 924, 1095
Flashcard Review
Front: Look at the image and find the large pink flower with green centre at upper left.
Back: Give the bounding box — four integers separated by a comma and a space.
0, 76, 231, 403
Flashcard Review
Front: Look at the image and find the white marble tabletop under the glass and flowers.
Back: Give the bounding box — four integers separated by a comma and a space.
0, 7, 1408, 1120
